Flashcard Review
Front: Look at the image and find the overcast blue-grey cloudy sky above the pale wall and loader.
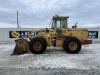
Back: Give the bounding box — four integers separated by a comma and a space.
0, 0, 100, 28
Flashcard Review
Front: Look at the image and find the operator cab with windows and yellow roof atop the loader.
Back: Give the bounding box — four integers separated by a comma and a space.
51, 15, 69, 29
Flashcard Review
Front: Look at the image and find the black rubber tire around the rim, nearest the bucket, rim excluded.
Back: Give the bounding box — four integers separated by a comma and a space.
29, 37, 47, 54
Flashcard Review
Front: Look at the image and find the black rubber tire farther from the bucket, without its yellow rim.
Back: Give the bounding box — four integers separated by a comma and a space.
63, 37, 82, 54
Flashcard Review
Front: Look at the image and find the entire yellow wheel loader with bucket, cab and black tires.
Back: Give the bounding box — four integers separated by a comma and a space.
12, 15, 92, 55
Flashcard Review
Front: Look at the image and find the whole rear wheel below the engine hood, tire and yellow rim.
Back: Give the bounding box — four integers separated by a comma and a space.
63, 37, 81, 54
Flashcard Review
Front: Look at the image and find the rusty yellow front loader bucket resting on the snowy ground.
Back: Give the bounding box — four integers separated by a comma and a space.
11, 39, 29, 55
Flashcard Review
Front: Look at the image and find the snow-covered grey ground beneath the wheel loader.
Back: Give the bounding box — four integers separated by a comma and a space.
0, 43, 100, 75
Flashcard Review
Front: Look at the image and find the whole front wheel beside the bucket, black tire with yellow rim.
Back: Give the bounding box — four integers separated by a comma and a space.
29, 37, 47, 54
